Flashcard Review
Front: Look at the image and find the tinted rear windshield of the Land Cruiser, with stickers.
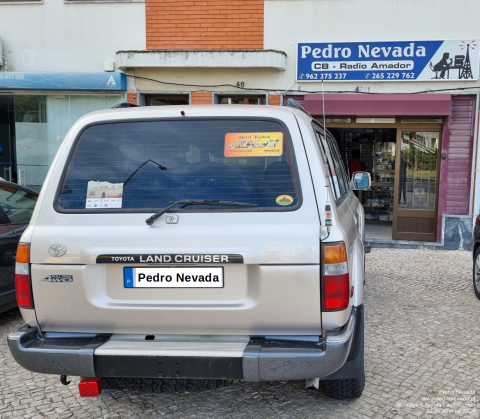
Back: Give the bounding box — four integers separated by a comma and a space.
57, 120, 301, 212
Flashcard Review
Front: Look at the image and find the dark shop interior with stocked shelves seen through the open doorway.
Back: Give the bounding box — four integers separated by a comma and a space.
329, 127, 398, 240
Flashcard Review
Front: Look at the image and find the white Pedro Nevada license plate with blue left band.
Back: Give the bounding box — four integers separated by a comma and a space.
123, 266, 223, 288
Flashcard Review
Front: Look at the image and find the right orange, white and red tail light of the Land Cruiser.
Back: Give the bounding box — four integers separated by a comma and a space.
322, 243, 353, 311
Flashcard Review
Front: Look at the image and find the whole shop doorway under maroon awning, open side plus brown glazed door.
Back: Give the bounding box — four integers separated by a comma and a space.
327, 118, 442, 241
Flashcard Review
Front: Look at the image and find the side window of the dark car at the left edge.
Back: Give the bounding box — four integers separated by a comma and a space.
0, 186, 37, 224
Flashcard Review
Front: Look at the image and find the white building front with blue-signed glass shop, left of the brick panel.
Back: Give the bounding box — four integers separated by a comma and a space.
0, 0, 145, 189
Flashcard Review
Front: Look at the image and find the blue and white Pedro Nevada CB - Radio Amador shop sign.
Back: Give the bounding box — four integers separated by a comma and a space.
297, 39, 479, 82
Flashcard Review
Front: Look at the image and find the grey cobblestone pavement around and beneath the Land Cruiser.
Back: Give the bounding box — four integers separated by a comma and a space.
0, 249, 480, 419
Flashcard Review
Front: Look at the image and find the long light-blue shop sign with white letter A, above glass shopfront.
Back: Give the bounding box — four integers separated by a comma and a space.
0, 71, 127, 91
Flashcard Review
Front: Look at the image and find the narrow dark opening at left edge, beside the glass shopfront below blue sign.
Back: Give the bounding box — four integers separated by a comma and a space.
0, 95, 17, 182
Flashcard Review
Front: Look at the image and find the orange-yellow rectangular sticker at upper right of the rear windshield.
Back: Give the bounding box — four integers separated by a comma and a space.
225, 132, 283, 157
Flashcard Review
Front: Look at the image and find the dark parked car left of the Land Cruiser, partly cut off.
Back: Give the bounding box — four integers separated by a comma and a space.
0, 181, 38, 313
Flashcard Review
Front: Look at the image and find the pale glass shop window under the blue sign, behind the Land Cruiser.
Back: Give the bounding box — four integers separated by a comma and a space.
12, 95, 124, 191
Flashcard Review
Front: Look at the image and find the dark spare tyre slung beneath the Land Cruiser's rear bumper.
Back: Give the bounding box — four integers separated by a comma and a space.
115, 377, 233, 393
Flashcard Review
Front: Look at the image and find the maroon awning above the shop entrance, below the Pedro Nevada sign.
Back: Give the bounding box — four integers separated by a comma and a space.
303, 93, 452, 116
